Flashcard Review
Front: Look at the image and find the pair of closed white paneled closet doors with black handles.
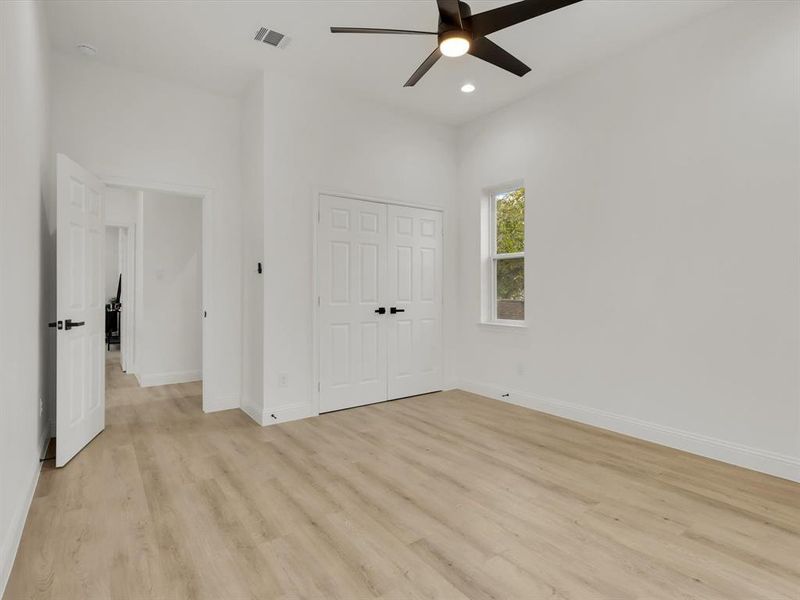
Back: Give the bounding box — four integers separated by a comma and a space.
317, 195, 442, 413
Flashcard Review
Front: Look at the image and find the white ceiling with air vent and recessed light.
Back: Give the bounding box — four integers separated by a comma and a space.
46, 0, 730, 124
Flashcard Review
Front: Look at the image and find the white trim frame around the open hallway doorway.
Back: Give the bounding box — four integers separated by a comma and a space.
100, 176, 215, 412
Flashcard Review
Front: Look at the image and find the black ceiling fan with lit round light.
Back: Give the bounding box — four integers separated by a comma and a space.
331, 0, 581, 87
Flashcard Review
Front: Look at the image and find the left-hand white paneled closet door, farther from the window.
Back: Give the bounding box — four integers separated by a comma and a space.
317, 196, 387, 412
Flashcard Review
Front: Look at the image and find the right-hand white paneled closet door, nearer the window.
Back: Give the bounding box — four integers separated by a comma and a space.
387, 205, 442, 400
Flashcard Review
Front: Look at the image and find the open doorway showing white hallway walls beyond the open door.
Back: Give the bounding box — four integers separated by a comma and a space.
105, 186, 204, 387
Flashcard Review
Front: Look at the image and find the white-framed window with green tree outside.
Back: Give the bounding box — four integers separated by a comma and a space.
486, 187, 525, 324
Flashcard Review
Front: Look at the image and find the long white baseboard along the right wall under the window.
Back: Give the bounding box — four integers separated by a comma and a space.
459, 381, 800, 482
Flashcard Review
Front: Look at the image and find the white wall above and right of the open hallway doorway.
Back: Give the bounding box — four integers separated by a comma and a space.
53, 55, 242, 410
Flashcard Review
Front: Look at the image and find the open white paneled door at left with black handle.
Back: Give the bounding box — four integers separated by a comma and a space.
56, 154, 105, 467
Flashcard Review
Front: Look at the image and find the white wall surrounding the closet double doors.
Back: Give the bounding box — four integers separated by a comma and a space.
253, 74, 458, 421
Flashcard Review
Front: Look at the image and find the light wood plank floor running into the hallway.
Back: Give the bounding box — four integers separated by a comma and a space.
5, 354, 800, 600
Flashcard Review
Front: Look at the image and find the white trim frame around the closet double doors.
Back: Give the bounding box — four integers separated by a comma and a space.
311, 188, 446, 416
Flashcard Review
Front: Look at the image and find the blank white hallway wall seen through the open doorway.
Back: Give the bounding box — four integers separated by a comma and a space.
136, 192, 203, 386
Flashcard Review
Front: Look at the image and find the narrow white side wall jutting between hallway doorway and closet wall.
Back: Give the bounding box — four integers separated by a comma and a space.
241, 74, 265, 422
